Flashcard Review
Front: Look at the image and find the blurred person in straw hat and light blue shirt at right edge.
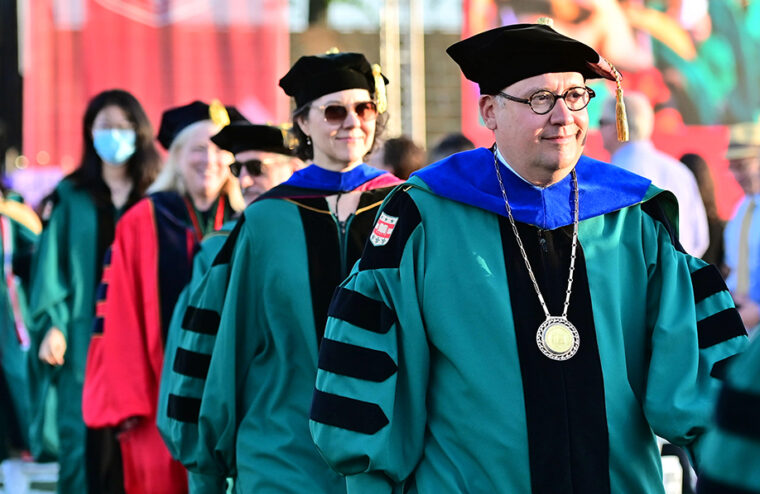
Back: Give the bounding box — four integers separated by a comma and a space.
723, 124, 760, 330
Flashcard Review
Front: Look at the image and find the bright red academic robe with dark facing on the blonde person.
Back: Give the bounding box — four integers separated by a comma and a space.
82, 193, 230, 494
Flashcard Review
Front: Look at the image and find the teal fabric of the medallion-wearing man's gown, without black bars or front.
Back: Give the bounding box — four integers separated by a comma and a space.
310, 178, 746, 494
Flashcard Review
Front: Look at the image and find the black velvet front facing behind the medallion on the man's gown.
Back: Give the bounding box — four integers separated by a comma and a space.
499, 216, 610, 494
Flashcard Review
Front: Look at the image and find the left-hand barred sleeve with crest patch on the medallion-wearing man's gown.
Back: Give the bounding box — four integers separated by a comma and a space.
310, 187, 430, 494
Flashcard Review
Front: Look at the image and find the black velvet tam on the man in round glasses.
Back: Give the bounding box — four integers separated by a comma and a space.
446, 24, 615, 94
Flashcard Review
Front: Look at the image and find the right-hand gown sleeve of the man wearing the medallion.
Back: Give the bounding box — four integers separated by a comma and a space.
643, 193, 747, 468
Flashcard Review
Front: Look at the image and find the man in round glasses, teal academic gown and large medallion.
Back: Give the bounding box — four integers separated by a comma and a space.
310, 24, 746, 494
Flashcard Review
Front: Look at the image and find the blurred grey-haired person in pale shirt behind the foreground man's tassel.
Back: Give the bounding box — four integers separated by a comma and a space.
599, 91, 710, 257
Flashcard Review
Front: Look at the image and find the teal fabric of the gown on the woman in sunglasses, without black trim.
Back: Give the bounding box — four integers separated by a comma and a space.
159, 191, 394, 494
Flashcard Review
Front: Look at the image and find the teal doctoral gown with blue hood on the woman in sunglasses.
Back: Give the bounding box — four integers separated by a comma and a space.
158, 165, 398, 494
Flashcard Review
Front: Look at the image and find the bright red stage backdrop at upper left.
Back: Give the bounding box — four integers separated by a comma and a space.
22, 0, 290, 171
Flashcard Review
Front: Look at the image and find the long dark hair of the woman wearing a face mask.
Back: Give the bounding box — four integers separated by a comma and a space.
68, 89, 161, 205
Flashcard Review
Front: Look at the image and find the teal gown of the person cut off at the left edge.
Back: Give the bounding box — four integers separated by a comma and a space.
0, 194, 42, 461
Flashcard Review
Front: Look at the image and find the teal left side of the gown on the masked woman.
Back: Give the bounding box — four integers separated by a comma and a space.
30, 179, 102, 493
